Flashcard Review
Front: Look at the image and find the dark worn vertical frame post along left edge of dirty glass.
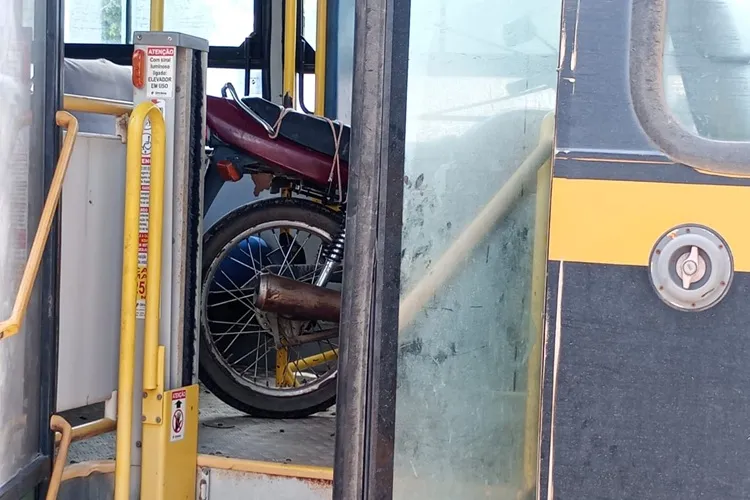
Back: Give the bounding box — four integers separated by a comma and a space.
333, 0, 411, 500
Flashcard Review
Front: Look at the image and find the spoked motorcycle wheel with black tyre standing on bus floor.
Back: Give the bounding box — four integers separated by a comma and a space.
199, 198, 343, 418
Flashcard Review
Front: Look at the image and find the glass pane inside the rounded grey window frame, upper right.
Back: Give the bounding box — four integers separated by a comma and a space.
664, 0, 750, 141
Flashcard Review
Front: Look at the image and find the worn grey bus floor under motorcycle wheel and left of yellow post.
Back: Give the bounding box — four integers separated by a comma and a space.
62, 386, 336, 467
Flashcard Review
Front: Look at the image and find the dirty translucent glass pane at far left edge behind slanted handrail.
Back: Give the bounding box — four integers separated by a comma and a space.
0, 0, 44, 484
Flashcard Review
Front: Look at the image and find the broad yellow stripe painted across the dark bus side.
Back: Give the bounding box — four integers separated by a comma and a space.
549, 178, 750, 272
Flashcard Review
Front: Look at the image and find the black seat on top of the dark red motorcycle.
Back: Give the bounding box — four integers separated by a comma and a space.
242, 97, 351, 163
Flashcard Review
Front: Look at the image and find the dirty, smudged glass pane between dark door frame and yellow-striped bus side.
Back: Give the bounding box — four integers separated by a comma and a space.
394, 0, 561, 500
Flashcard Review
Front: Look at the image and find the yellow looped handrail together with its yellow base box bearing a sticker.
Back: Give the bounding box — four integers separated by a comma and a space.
121, 102, 198, 500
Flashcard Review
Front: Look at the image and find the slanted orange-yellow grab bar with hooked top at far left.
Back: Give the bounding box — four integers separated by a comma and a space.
0, 111, 78, 339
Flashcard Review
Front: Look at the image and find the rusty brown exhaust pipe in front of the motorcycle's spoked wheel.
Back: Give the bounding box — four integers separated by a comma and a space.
255, 274, 341, 323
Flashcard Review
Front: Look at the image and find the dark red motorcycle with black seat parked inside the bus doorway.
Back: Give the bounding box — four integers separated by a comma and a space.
199, 84, 350, 418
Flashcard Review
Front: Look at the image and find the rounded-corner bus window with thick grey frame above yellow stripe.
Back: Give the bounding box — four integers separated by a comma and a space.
629, 0, 750, 177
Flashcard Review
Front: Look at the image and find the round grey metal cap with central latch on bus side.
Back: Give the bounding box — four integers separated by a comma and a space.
649, 224, 734, 311
